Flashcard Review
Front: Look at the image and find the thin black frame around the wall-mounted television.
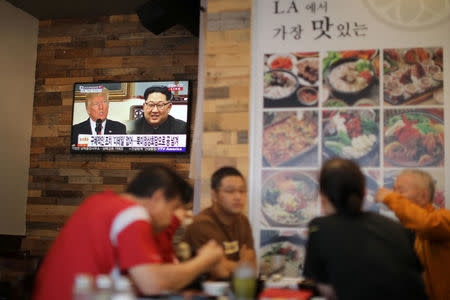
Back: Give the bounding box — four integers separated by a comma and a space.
69, 79, 193, 156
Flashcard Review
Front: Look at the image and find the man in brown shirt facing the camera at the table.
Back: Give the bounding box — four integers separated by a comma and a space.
183, 167, 256, 278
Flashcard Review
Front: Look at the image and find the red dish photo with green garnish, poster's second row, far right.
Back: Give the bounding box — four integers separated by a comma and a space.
383, 109, 445, 167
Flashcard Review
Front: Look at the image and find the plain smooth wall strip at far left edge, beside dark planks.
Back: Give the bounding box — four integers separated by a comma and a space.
0, 0, 39, 235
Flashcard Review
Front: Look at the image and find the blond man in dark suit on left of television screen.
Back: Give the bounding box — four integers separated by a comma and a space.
71, 88, 126, 146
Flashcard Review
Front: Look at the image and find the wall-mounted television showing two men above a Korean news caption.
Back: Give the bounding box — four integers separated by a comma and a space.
70, 80, 192, 153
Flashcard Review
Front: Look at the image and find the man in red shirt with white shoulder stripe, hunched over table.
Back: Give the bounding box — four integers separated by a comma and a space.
34, 165, 223, 300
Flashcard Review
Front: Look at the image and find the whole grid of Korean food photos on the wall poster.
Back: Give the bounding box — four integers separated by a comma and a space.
258, 47, 445, 275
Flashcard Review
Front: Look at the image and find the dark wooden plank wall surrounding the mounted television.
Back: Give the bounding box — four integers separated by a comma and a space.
22, 15, 198, 255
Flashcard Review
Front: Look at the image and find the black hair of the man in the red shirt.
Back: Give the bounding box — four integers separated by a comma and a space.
126, 164, 193, 204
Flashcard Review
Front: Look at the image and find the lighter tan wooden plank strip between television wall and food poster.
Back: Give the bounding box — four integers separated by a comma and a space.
200, 0, 252, 208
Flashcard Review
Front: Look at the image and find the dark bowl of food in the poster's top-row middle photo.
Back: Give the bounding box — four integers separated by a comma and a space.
325, 57, 375, 101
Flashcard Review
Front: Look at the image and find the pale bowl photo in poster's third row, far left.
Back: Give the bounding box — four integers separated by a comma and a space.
262, 171, 319, 226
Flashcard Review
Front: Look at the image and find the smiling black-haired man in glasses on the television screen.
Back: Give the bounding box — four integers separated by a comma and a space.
127, 86, 186, 134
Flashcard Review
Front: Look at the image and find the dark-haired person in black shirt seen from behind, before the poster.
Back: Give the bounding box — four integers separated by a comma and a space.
303, 158, 427, 300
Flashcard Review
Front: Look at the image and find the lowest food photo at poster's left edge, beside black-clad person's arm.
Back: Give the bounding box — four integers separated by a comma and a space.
259, 230, 307, 279
